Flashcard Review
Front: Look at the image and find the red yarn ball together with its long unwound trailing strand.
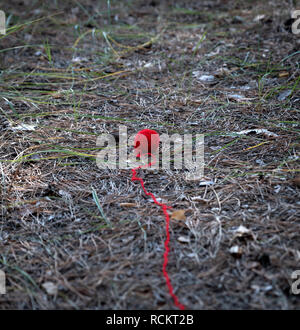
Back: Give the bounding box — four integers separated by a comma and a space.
131, 129, 185, 310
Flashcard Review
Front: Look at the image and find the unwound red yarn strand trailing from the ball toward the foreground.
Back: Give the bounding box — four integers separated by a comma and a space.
131, 153, 185, 310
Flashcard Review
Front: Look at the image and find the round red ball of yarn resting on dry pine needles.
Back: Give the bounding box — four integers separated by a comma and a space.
133, 128, 159, 157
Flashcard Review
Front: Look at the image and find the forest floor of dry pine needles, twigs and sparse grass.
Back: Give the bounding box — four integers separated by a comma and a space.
0, 0, 300, 310
